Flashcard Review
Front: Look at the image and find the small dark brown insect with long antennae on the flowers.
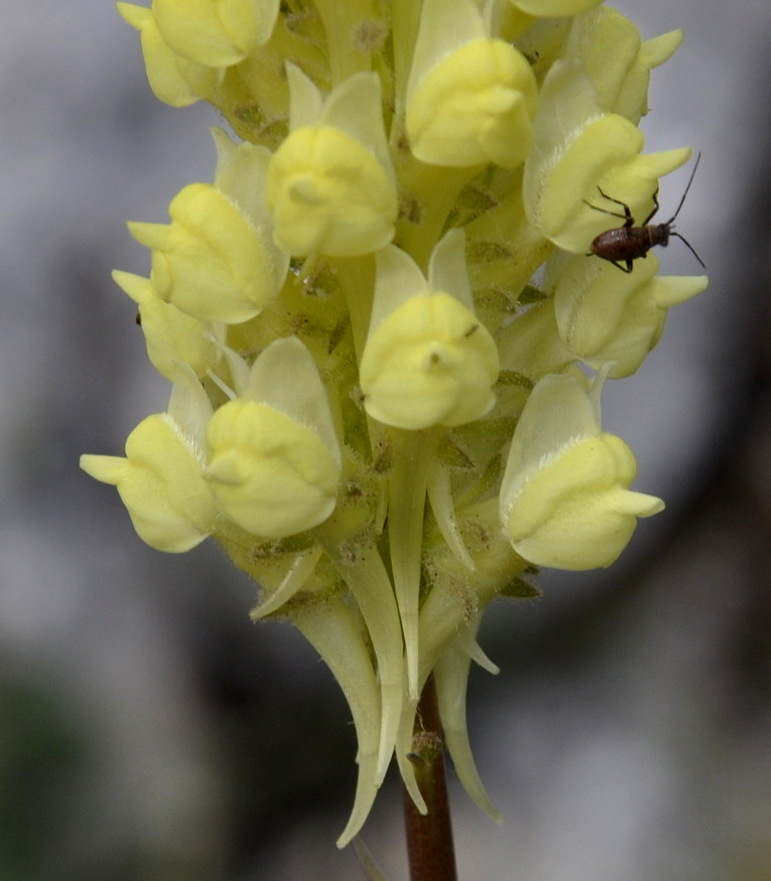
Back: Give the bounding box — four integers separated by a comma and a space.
584, 153, 704, 272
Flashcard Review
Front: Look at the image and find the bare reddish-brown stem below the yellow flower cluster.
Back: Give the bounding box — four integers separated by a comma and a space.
402, 676, 458, 881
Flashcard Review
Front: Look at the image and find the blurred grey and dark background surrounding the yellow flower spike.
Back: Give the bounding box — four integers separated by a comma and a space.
0, 0, 771, 881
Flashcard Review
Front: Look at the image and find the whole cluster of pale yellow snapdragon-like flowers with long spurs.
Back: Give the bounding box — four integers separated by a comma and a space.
82, 0, 706, 844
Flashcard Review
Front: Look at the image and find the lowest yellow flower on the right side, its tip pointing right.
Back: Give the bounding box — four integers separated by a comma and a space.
499, 375, 664, 570
